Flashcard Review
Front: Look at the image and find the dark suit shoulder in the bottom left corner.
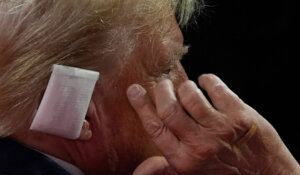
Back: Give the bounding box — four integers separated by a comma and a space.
0, 138, 70, 175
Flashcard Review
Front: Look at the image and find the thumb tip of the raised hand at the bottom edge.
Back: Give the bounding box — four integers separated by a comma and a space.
133, 156, 178, 175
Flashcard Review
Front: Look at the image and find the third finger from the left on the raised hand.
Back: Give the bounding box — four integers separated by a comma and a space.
178, 80, 217, 127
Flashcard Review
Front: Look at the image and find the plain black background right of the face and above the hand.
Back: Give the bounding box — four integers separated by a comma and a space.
182, 0, 300, 162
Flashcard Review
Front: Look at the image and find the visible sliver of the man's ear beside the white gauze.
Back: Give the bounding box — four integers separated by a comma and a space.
78, 100, 95, 141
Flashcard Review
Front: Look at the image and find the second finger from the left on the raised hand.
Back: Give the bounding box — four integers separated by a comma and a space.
154, 80, 199, 139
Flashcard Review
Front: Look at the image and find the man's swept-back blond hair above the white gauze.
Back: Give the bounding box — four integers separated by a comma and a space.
0, 0, 201, 137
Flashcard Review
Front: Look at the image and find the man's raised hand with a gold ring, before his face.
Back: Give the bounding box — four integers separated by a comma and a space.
128, 74, 299, 175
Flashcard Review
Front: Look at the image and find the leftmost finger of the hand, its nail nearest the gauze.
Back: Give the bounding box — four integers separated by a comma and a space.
127, 84, 179, 156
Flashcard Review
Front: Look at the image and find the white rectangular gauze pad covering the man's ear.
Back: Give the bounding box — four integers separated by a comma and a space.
30, 65, 99, 139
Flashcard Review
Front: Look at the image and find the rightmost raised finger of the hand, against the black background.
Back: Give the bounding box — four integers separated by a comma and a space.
198, 74, 243, 112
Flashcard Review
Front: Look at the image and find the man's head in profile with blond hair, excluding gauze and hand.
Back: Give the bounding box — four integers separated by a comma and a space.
0, 0, 202, 174
